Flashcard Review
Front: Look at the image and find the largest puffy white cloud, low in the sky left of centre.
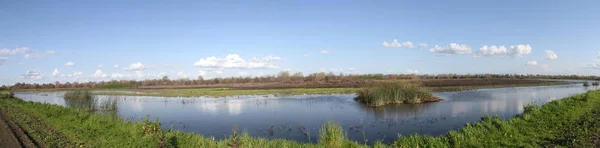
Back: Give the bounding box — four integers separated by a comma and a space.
194, 54, 282, 71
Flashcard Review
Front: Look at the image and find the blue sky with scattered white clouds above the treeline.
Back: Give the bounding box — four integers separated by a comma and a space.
0, 0, 600, 85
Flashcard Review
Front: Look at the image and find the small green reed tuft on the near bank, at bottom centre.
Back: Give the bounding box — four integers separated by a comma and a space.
319, 121, 346, 147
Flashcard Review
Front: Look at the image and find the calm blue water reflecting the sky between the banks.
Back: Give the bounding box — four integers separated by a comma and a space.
15, 84, 598, 143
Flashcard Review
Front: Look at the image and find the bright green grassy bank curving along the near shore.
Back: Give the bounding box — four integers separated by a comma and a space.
0, 91, 600, 147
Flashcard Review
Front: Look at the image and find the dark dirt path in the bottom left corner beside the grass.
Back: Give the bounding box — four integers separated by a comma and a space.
0, 111, 40, 148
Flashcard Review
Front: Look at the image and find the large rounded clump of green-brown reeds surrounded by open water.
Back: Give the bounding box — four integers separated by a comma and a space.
354, 81, 440, 107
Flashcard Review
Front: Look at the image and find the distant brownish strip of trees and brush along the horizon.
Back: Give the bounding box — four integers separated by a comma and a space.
0, 71, 600, 90
